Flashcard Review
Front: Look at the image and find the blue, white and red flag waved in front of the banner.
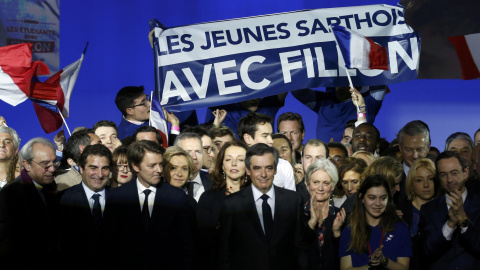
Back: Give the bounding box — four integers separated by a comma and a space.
330, 24, 388, 70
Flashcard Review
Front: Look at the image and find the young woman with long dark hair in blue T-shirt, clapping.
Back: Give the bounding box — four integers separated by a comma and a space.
339, 174, 412, 270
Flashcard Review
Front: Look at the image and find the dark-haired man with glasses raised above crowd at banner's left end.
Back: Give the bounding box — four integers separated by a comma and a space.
115, 86, 150, 139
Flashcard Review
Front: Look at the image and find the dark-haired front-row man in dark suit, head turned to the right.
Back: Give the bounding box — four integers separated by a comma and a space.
104, 141, 194, 269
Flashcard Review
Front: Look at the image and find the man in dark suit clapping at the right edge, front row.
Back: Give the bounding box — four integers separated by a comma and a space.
419, 151, 480, 269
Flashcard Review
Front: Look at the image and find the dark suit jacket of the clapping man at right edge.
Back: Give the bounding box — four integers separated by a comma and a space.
419, 190, 480, 269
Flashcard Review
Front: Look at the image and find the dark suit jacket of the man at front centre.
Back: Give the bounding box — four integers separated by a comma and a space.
218, 186, 315, 270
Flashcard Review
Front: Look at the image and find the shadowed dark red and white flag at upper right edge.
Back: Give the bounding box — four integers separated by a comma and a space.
448, 33, 480, 80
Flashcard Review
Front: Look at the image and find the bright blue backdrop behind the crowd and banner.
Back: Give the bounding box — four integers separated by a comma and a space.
0, 0, 480, 150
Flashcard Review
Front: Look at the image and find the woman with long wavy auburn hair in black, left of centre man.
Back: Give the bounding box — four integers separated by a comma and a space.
196, 140, 250, 269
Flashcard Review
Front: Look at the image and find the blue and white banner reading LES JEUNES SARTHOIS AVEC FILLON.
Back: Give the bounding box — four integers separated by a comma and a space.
150, 5, 420, 112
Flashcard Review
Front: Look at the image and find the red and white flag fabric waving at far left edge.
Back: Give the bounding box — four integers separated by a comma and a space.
0, 43, 50, 106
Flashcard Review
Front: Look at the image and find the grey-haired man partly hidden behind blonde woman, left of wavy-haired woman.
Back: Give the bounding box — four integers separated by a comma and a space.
174, 132, 212, 202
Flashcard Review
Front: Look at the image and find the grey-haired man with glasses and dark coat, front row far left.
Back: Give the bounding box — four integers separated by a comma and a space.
0, 138, 58, 269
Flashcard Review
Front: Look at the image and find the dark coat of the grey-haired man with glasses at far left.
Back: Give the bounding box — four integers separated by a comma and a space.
0, 170, 58, 269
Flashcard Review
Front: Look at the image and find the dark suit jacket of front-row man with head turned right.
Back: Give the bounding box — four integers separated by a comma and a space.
104, 180, 194, 269
